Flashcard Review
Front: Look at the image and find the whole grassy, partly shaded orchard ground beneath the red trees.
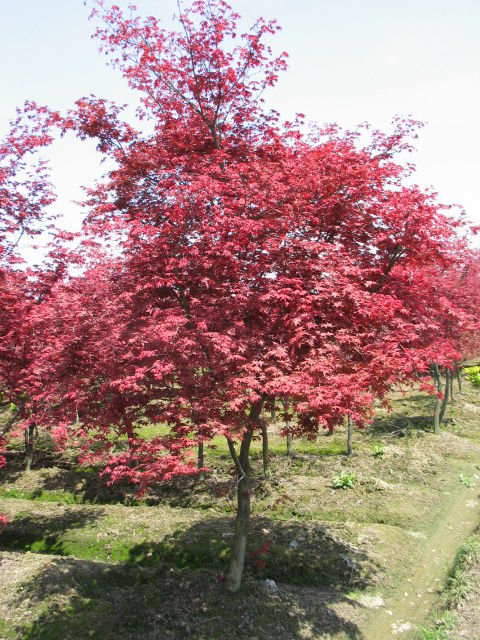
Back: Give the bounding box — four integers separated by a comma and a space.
0, 378, 480, 640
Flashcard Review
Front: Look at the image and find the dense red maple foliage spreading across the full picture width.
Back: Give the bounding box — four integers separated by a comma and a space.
0, 0, 480, 502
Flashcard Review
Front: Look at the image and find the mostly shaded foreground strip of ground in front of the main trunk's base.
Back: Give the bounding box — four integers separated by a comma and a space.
0, 552, 368, 640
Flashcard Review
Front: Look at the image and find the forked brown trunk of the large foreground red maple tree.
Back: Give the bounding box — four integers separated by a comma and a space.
225, 399, 264, 592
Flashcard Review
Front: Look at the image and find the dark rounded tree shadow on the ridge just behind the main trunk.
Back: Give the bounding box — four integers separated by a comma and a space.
129, 517, 379, 592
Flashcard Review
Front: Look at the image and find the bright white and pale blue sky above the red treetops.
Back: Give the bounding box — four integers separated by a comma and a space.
0, 0, 480, 256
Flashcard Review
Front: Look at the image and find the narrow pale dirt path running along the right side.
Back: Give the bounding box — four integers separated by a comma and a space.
363, 487, 480, 640
